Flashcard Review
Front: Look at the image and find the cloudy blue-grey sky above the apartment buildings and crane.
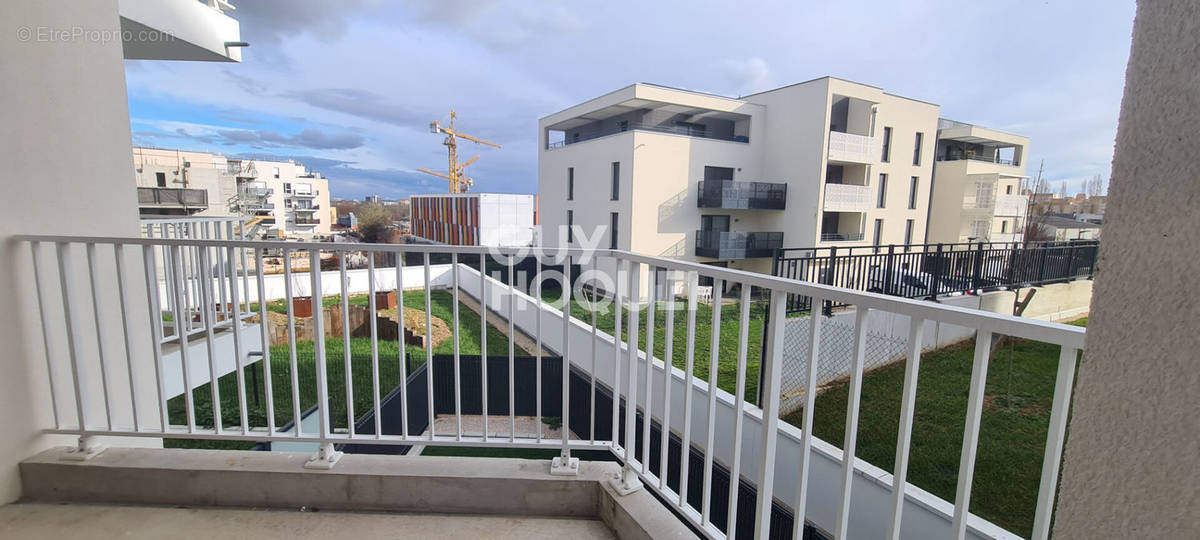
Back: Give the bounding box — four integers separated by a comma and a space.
126, 0, 1134, 198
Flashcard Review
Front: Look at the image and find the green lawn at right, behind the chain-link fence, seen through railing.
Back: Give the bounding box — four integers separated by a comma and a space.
785, 319, 1087, 536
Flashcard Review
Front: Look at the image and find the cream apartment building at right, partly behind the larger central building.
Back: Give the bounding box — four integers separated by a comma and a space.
925, 119, 1030, 244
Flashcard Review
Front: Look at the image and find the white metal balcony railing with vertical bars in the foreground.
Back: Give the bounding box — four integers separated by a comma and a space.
17, 236, 1084, 539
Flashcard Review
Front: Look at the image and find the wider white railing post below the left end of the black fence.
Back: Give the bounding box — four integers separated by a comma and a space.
748, 287, 787, 538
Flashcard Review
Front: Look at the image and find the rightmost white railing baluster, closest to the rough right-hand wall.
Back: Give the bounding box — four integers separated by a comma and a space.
1031, 347, 1079, 539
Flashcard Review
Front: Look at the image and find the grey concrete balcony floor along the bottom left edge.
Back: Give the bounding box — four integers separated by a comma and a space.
0, 503, 616, 540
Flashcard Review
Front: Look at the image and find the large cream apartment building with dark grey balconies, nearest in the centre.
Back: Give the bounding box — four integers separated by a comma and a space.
538, 77, 938, 283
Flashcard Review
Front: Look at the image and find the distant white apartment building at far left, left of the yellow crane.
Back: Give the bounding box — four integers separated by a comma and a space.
133, 148, 332, 238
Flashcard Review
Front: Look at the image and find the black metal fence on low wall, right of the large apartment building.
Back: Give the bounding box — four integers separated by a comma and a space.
773, 240, 1099, 312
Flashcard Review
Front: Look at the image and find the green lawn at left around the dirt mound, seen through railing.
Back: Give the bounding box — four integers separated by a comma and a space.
164, 290, 526, 449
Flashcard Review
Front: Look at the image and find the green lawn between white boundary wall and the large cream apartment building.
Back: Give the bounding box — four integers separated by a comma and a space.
542, 287, 766, 402
